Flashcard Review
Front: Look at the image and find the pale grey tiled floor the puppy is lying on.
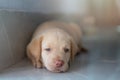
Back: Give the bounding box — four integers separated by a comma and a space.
0, 55, 120, 80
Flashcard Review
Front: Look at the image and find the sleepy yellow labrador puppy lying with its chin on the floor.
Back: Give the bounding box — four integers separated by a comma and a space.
27, 21, 86, 72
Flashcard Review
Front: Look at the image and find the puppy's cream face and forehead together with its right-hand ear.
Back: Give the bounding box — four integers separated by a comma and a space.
38, 30, 77, 72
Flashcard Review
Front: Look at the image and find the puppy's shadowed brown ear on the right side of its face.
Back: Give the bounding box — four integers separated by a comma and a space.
70, 40, 78, 62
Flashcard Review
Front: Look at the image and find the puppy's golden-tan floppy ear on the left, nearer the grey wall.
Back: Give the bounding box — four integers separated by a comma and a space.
27, 36, 43, 68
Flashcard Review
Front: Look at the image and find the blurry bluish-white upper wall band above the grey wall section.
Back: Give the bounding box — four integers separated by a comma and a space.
0, 0, 88, 14
